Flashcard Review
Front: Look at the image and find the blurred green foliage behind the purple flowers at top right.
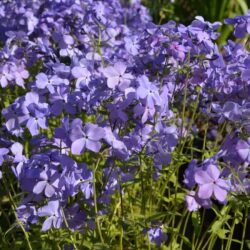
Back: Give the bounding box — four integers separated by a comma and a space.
142, 0, 250, 45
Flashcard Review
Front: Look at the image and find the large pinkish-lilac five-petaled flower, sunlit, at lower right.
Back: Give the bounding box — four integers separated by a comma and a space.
194, 165, 227, 202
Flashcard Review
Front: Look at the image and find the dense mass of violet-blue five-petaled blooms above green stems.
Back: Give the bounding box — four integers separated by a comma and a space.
0, 0, 250, 245
